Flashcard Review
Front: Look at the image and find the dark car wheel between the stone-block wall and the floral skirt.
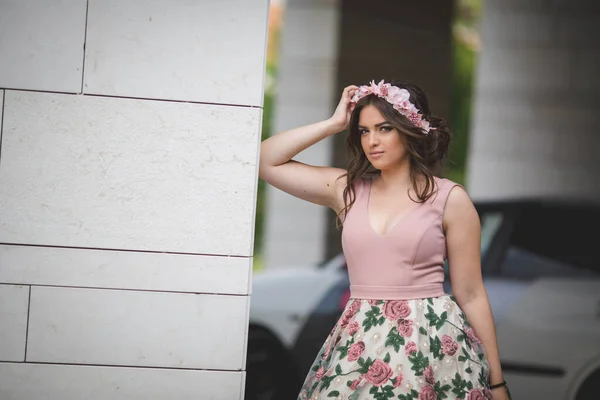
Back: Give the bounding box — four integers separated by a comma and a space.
244, 327, 299, 400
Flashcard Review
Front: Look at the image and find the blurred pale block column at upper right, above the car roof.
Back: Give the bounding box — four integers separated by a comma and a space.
467, 0, 600, 201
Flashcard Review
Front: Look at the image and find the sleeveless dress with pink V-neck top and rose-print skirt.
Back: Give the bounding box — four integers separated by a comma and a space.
298, 178, 492, 400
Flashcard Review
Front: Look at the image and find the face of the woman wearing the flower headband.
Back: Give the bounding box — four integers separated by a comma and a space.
358, 104, 407, 170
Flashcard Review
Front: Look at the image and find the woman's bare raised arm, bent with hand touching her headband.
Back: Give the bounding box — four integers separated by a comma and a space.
259, 86, 356, 212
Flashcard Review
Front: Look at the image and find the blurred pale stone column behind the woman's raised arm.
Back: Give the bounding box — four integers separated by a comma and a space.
264, 0, 341, 268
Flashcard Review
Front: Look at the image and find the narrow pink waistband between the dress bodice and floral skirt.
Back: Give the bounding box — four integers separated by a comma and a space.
350, 283, 446, 300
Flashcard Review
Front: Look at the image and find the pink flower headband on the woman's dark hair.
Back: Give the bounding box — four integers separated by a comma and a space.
350, 81, 431, 134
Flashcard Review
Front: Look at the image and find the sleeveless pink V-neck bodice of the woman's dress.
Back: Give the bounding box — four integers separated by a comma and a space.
342, 178, 456, 300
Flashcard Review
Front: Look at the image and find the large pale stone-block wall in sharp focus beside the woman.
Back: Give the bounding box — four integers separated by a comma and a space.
0, 0, 268, 400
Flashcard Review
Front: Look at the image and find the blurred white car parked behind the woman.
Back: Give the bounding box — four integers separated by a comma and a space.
246, 200, 600, 400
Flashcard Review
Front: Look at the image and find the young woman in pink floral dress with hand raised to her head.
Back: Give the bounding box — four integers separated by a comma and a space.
260, 81, 509, 400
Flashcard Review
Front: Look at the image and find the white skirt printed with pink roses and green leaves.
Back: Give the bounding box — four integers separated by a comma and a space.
298, 295, 492, 400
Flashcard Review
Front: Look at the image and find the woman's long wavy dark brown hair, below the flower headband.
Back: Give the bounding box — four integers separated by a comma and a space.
336, 81, 452, 228
